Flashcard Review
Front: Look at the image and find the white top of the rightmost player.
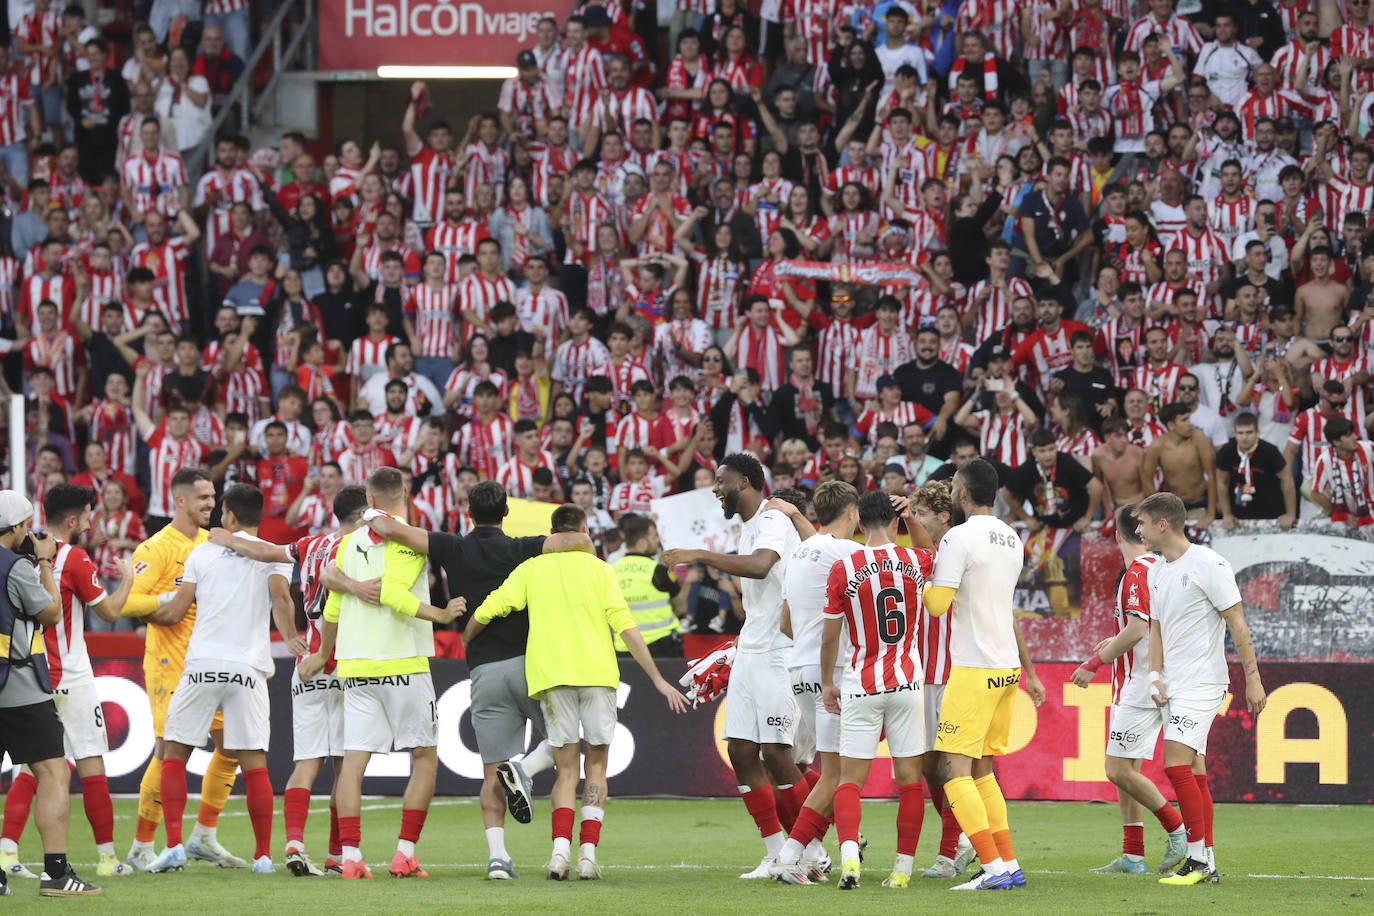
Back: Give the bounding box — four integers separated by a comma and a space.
1150, 544, 1241, 686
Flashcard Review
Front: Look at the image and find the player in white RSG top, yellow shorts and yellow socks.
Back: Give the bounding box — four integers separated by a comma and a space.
922, 459, 1025, 890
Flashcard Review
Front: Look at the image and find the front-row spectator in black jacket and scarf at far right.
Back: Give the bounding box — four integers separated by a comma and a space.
1216, 411, 1297, 531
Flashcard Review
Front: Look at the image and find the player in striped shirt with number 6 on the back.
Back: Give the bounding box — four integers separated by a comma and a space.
820, 493, 934, 889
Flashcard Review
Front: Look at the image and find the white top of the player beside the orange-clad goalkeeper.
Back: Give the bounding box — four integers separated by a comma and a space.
181, 531, 291, 674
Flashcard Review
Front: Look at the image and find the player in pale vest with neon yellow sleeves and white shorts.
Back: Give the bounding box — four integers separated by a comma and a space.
316, 467, 464, 879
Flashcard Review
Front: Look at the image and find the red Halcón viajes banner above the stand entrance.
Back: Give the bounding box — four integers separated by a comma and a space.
319, 0, 573, 70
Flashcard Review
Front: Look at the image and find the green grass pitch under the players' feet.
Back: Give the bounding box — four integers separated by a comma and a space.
0, 797, 1374, 916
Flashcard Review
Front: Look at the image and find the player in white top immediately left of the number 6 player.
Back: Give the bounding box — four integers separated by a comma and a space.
774, 481, 859, 884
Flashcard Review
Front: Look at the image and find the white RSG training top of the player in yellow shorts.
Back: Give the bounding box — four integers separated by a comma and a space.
930, 515, 1025, 667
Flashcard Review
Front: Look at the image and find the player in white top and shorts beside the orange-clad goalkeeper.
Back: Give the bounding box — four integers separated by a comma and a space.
148, 483, 305, 875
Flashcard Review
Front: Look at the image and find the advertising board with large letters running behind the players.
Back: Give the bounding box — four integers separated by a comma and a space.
10, 656, 1374, 803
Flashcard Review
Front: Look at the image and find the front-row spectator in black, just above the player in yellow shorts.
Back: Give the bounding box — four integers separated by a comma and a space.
1002, 430, 1102, 534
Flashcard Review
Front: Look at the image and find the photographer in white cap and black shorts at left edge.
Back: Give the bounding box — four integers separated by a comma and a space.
0, 490, 100, 897
